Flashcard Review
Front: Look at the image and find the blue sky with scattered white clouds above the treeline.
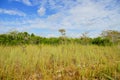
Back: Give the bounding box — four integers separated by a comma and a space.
0, 0, 120, 37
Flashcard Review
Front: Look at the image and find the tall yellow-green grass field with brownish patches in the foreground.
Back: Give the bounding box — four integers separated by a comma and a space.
0, 44, 120, 80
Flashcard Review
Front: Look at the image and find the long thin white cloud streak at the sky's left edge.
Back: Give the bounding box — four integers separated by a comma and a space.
0, 8, 26, 16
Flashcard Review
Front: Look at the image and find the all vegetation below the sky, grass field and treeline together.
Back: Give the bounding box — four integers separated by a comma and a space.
0, 29, 120, 80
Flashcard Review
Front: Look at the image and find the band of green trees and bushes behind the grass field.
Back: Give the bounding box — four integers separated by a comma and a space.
0, 30, 120, 46
